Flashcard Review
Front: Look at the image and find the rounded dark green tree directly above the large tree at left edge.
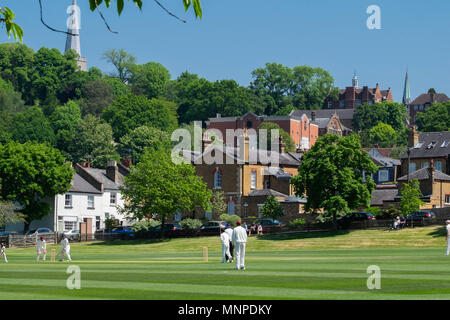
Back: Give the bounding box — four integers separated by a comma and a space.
11, 106, 56, 145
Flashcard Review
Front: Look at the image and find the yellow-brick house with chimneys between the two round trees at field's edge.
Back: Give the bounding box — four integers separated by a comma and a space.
180, 136, 306, 222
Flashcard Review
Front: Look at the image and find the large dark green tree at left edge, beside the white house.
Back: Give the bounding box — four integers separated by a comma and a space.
0, 142, 73, 231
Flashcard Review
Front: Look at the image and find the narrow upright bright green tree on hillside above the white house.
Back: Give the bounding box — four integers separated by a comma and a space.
49, 101, 81, 160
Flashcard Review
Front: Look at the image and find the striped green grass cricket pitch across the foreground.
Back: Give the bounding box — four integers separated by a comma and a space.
0, 227, 450, 300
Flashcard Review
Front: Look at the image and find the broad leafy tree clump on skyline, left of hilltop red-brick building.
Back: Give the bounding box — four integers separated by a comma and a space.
251, 63, 337, 115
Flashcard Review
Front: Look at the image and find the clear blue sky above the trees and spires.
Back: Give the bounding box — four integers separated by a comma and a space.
1, 0, 450, 101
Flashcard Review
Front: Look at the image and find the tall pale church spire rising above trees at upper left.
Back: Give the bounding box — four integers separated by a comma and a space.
65, 0, 87, 71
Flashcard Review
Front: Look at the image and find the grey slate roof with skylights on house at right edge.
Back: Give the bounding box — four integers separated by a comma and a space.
401, 131, 450, 159
